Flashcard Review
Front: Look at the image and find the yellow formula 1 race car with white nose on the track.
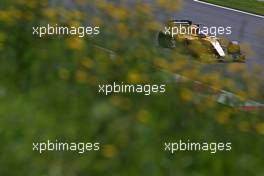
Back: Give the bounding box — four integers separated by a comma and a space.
158, 20, 246, 62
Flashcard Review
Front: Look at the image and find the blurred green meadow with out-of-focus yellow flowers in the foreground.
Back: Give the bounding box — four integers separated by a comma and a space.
0, 0, 264, 176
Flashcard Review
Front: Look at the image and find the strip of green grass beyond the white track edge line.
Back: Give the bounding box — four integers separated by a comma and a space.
202, 0, 264, 15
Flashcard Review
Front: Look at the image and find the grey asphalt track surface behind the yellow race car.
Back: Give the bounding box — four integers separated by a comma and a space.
172, 0, 264, 72
